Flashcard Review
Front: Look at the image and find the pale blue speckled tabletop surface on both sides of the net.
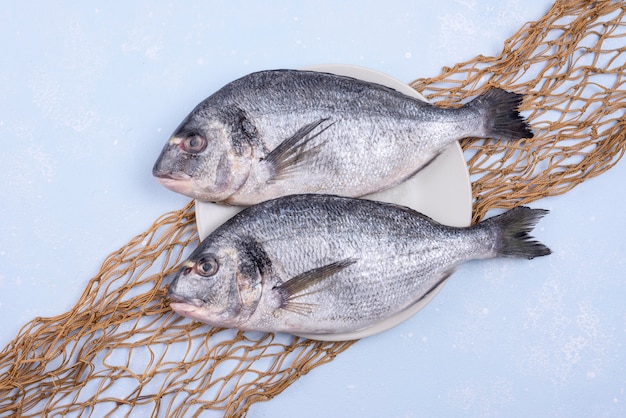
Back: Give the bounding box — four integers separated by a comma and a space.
0, 0, 626, 417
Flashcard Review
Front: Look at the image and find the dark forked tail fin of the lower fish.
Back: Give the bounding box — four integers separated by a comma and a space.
485, 206, 552, 260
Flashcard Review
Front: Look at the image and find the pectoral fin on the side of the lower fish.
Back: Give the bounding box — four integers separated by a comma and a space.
274, 258, 357, 315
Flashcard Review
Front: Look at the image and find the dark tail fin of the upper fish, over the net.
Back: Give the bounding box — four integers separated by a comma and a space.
467, 88, 533, 140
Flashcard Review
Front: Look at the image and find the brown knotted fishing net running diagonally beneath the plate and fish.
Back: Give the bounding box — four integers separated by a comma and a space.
0, 0, 626, 417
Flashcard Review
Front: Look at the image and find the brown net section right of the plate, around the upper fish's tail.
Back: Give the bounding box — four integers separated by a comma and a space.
411, 0, 626, 221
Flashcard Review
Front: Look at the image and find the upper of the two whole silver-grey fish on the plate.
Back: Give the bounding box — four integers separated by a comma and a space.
152, 70, 533, 206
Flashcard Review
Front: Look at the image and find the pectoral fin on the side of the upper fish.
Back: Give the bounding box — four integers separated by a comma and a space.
265, 118, 335, 181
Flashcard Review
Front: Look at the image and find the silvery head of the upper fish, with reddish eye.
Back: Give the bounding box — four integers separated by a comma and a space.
152, 104, 252, 202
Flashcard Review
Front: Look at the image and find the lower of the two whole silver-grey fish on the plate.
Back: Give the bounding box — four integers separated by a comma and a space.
167, 194, 551, 340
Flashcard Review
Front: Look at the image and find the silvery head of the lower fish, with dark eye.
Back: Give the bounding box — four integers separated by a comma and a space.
167, 245, 262, 328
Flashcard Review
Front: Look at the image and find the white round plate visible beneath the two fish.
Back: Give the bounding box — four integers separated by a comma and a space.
196, 64, 472, 341
